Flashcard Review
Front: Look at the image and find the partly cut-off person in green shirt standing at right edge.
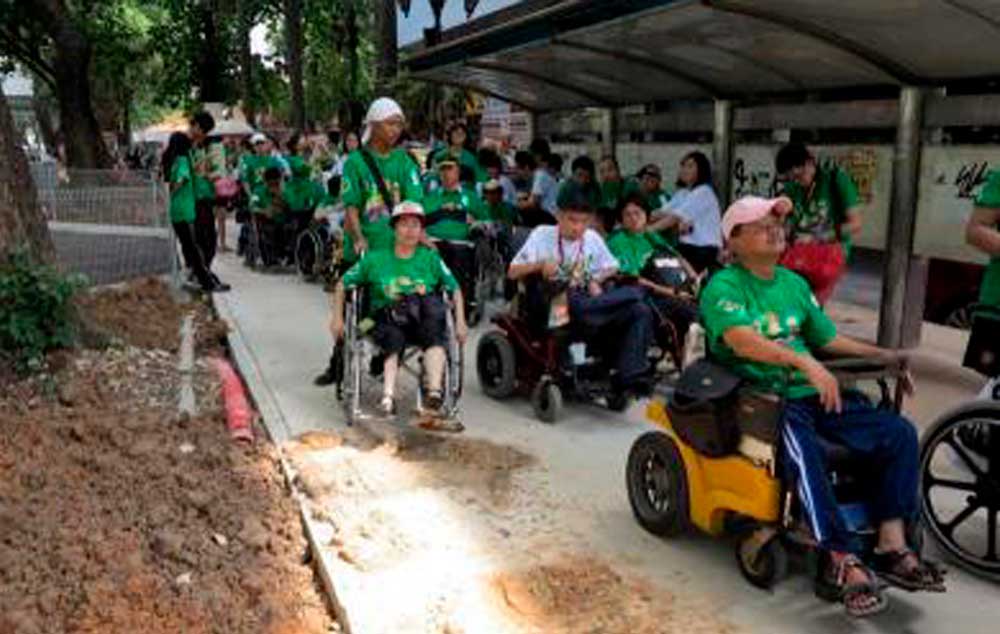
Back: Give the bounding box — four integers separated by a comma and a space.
962, 171, 1000, 378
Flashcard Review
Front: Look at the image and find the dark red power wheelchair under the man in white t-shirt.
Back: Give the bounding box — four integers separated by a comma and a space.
476, 281, 664, 423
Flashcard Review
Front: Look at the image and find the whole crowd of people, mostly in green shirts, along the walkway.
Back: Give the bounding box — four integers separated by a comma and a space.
163, 98, 1000, 616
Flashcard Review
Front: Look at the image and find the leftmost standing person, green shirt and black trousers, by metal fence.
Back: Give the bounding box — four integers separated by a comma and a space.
161, 132, 229, 293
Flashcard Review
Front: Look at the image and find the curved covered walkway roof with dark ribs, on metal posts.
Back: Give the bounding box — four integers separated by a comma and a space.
405, 0, 1000, 112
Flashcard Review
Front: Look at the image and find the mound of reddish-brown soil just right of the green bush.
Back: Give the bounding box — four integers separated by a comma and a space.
76, 277, 190, 352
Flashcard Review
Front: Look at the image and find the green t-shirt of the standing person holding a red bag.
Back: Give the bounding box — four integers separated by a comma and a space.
783, 165, 860, 254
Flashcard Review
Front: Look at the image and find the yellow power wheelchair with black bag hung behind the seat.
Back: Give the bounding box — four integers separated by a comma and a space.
625, 359, 923, 600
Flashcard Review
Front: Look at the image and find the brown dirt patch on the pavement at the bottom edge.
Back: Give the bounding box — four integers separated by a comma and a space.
492, 557, 737, 634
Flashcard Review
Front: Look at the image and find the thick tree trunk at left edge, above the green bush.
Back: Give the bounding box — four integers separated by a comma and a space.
0, 94, 55, 262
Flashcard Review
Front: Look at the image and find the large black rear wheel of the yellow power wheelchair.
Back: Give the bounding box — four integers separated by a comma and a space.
625, 431, 688, 537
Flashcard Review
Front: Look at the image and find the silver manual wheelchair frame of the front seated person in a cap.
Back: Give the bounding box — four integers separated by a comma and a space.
337, 288, 464, 425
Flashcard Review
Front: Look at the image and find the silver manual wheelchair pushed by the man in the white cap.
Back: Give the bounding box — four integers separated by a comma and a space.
335, 288, 464, 426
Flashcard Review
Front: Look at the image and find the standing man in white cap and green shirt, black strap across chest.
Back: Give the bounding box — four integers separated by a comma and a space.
313, 97, 423, 386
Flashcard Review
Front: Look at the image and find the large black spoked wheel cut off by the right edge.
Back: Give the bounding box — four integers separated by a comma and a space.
920, 403, 1000, 580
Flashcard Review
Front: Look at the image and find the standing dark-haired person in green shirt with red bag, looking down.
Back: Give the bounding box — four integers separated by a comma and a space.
775, 142, 861, 304
